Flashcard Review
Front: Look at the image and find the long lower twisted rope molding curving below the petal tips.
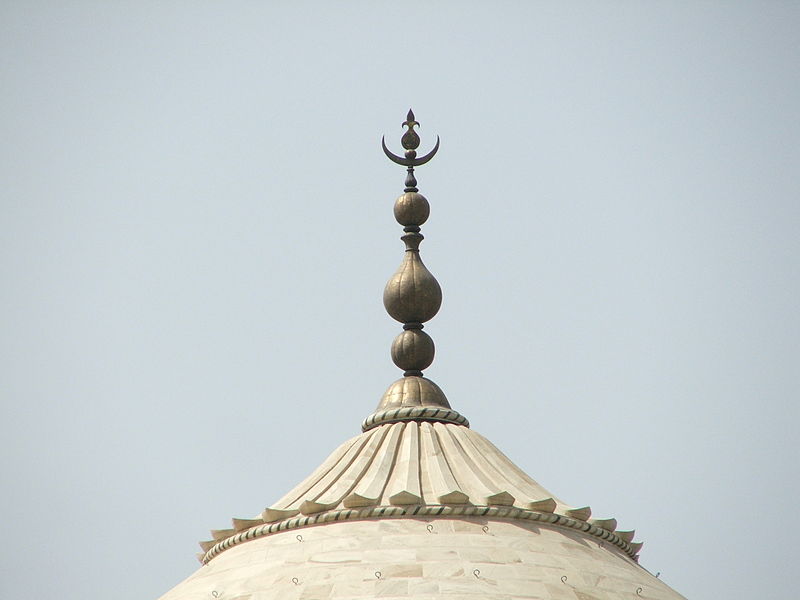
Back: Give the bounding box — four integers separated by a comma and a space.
201, 505, 641, 564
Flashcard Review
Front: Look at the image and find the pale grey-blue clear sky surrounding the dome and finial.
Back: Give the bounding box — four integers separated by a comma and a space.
0, 0, 800, 600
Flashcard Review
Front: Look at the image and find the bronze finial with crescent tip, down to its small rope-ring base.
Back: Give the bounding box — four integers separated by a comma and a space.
362, 110, 468, 431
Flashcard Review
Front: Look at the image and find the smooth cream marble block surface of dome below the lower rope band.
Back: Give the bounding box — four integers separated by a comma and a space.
161, 517, 683, 600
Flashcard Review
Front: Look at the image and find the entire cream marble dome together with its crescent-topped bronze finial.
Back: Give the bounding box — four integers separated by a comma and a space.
161, 111, 683, 600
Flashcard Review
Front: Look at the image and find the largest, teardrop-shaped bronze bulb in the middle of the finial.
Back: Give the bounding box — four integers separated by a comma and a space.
383, 250, 442, 323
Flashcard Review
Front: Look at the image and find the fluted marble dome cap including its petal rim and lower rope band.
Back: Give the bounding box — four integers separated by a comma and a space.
201, 420, 640, 563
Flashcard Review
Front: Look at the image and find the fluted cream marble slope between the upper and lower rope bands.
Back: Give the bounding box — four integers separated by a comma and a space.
261, 420, 588, 521
